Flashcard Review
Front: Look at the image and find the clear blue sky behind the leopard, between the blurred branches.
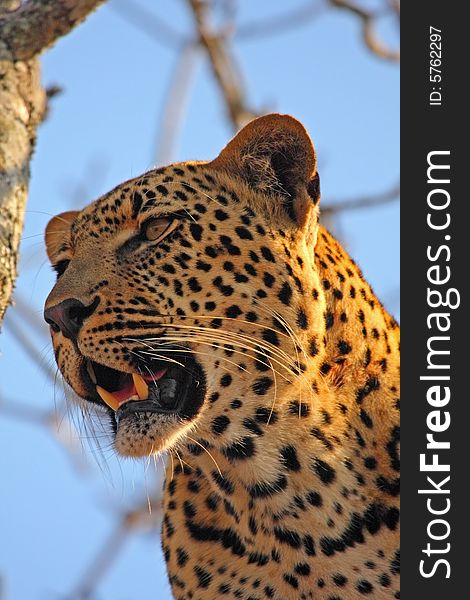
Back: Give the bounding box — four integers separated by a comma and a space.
0, 0, 399, 600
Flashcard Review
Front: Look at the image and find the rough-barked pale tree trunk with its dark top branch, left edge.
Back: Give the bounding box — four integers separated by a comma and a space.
0, 0, 104, 325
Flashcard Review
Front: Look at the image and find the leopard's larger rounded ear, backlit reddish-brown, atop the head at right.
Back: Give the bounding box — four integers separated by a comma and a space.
210, 114, 320, 224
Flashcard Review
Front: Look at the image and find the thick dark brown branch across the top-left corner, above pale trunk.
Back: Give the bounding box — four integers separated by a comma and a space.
0, 0, 104, 60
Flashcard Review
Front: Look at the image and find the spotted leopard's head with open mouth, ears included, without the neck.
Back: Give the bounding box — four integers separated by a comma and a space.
44, 114, 325, 456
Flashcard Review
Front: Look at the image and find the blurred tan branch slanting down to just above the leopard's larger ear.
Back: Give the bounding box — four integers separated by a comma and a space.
187, 0, 256, 130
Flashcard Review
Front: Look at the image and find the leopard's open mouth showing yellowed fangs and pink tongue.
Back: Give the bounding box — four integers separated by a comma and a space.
82, 353, 205, 424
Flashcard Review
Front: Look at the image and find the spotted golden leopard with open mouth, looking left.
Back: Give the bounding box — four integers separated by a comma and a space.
44, 114, 400, 600
